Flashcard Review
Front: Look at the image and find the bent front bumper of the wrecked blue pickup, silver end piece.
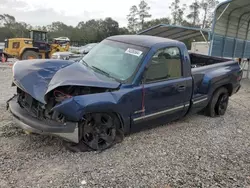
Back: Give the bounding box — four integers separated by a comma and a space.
7, 97, 79, 143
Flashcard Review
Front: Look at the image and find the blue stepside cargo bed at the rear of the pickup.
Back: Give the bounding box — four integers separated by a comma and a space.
190, 54, 241, 113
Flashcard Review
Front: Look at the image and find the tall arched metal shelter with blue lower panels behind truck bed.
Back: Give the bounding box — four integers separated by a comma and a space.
210, 0, 250, 58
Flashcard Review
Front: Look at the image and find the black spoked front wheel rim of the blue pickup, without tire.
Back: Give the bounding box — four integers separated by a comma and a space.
83, 113, 116, 150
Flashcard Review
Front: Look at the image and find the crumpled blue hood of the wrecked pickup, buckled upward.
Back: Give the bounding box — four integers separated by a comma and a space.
13, 59, 119, 103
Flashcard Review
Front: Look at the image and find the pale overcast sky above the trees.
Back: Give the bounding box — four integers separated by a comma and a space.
0, 0, 222, 27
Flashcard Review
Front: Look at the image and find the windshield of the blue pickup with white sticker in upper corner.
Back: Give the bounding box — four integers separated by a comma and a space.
82, 40, 147, 81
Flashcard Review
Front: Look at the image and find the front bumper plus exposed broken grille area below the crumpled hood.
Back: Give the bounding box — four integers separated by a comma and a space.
7, 87, 79, 143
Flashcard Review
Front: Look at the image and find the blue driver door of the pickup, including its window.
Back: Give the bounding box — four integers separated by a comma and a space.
134, 47, 189, 124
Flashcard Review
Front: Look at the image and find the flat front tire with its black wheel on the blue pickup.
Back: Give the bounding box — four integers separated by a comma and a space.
64, 113, 124, 152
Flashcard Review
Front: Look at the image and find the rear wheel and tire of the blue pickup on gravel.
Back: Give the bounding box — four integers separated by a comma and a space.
205, 87, 229, 117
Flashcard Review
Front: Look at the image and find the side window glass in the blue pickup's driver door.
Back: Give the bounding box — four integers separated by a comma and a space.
146, 47, 182, 82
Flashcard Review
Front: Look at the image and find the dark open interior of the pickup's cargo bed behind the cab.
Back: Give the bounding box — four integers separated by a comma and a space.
189, 53, 230, 68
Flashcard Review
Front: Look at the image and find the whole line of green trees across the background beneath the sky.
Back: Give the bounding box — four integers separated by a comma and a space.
0, 0, 218, 43
